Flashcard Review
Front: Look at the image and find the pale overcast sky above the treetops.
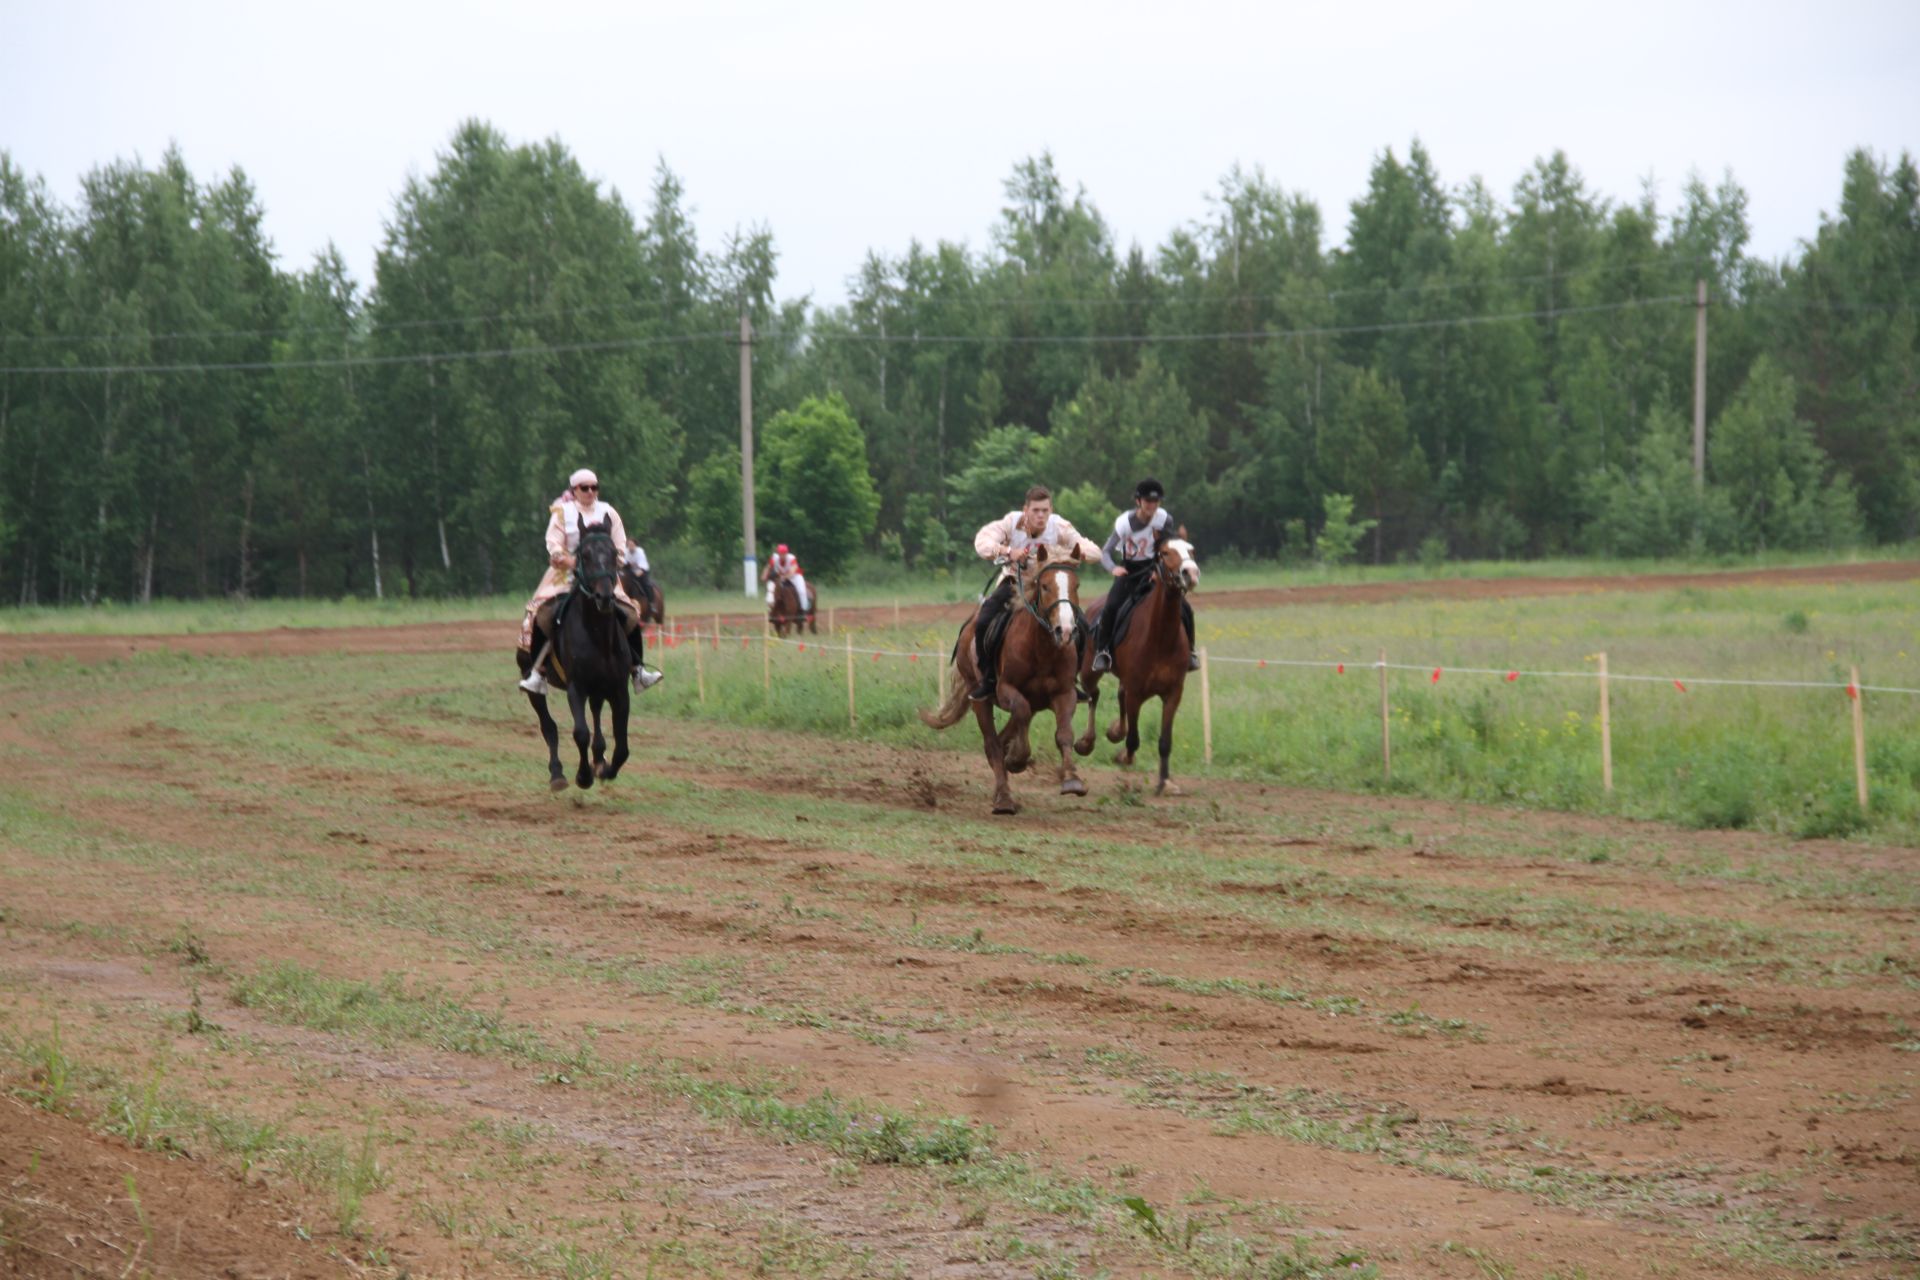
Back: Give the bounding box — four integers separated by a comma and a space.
0, 0, 1920, 305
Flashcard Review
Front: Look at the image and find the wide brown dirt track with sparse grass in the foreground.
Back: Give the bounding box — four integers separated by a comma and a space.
0, 614, 1920, 1276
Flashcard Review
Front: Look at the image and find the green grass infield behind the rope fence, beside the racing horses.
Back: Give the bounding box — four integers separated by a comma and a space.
622, 585, 1920, 842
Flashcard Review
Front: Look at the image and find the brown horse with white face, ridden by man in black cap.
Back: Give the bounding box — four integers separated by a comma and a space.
1073, 537, 1200, 794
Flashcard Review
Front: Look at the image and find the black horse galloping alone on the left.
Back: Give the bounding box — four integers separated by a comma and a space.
518, 516, 634, 791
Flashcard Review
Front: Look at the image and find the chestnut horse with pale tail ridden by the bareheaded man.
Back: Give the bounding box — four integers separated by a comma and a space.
920, 545, 1087, 814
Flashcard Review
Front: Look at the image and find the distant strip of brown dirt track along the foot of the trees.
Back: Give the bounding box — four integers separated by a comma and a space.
0, 560, 1920, 664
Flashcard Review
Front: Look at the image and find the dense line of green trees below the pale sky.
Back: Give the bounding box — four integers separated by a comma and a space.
0, 121, 1920, 604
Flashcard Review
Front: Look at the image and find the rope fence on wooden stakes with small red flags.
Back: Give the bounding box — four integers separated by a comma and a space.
647, 603, 1920, 814
